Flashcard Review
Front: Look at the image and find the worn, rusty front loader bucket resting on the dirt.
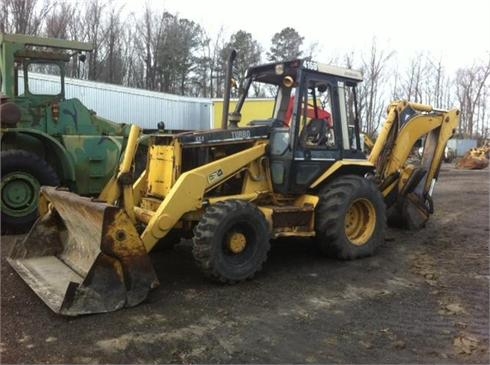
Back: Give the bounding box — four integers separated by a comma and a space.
7, 187, 158, 316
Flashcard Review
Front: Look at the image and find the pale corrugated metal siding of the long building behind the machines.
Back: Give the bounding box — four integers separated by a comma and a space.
19, 73, 212, 129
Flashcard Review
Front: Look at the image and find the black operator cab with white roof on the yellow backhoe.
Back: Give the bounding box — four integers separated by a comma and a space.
233, 60, 366, 194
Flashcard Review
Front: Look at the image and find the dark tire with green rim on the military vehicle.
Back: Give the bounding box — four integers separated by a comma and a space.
1, 150, 60, 234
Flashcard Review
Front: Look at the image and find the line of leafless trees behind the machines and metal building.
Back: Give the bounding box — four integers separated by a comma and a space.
0, 0, 490, 132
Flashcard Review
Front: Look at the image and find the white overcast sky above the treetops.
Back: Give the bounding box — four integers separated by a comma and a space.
116, 0, 490, 72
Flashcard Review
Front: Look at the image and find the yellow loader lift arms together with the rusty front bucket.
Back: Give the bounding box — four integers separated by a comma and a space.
8, 126, 267, 316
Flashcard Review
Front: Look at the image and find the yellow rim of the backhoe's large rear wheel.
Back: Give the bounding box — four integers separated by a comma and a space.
345, 199, 376, 246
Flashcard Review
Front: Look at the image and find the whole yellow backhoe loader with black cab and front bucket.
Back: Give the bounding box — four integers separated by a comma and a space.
8, 54, 459, 315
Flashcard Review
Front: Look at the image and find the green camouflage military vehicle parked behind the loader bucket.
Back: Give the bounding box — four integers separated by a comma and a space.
0, 33, 134, 233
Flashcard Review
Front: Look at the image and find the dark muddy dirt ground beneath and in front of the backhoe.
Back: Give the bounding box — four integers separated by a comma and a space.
0, 165, 490, 364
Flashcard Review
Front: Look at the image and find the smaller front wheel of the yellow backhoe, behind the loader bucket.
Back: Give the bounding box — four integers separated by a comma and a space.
192, 200, 270, 284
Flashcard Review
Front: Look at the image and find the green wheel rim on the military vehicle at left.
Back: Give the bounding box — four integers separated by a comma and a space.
2, 172, 40, 217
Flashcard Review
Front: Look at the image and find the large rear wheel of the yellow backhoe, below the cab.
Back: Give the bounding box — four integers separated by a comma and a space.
315, 175, 386, 260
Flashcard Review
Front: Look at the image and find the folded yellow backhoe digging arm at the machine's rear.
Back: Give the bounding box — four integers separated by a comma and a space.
369, 101, 459, 228
